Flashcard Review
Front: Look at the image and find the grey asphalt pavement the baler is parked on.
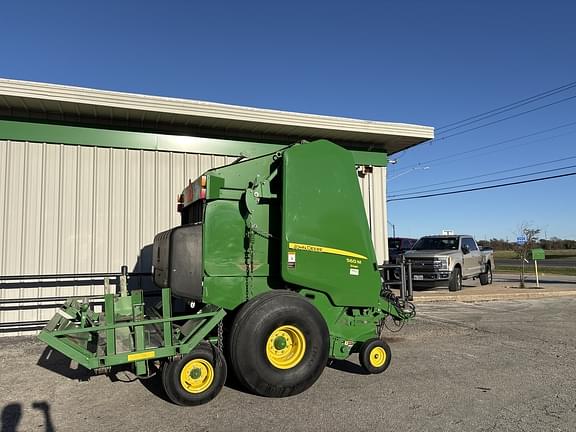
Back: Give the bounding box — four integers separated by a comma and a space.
0, 296, 576, 432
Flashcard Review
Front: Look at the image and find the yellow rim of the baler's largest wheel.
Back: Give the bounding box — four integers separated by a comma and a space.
266, 325, 306, 369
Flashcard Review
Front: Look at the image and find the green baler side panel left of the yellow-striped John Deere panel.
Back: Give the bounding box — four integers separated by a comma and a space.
203, 151, 282, 309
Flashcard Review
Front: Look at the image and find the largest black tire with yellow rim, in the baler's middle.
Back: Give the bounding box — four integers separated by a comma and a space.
230, 291, 330, 397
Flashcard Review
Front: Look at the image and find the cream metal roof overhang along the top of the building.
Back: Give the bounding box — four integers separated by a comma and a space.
0, 78, 434, 154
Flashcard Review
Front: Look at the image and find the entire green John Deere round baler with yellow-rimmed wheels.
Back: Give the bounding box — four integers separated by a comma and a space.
40, 140, 414, 405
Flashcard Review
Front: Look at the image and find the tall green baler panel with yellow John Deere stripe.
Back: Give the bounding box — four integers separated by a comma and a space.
281, 140, 380, 307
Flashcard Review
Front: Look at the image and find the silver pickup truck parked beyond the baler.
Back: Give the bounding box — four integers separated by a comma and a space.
404, 235, 494, 291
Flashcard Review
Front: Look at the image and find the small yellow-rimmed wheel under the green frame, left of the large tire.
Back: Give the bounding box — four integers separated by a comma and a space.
162, 342, 227, 405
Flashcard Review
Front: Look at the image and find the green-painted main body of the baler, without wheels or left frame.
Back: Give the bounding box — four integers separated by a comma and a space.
198, 140, 403, 358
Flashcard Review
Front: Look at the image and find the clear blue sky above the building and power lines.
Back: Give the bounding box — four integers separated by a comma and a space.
0, 0, 576, 239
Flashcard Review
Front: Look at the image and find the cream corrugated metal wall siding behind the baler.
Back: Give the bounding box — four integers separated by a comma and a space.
0, 141, 386, 335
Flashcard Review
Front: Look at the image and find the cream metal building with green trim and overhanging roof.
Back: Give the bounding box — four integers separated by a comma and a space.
0, 79, 434, 335
